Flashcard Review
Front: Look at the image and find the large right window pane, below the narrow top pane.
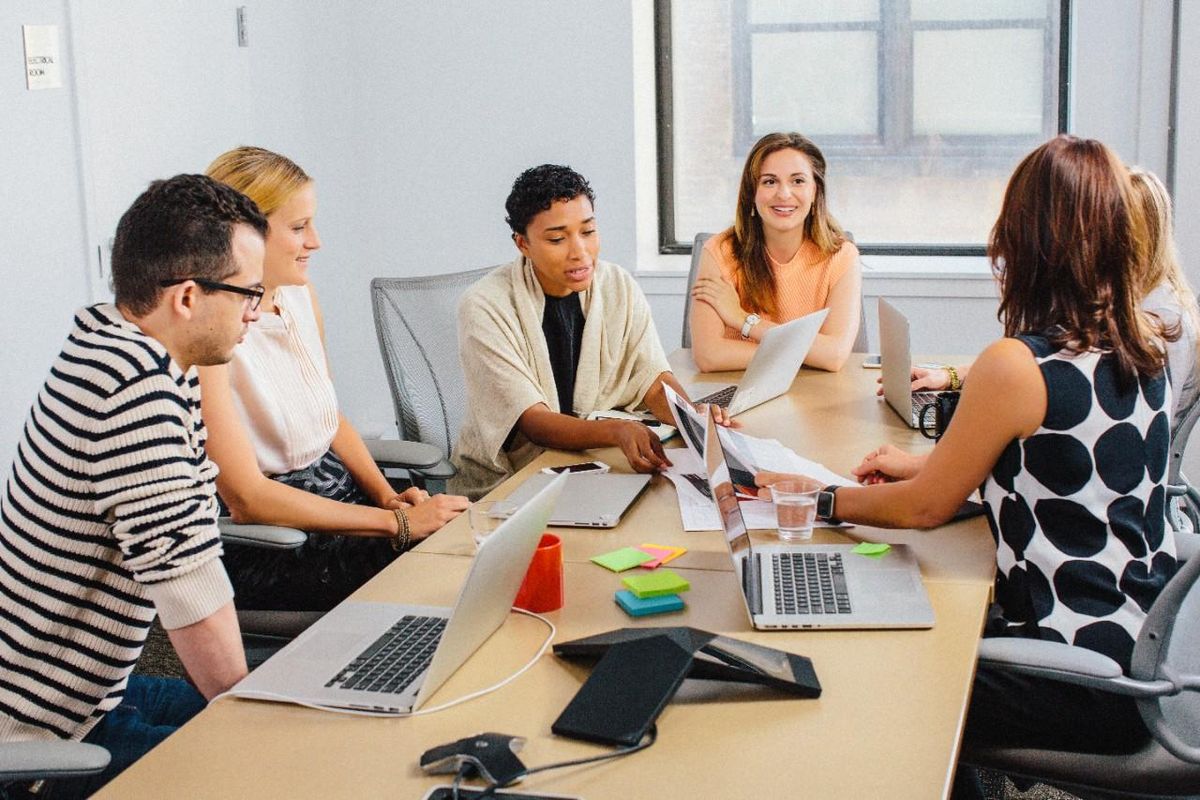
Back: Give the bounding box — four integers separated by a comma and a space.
912, 29, 1044, 137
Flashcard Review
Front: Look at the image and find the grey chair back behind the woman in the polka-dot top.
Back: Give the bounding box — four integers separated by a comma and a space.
1129, 558, 1200, 764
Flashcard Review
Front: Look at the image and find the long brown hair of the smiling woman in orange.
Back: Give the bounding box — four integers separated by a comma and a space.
725, 133, 846, 314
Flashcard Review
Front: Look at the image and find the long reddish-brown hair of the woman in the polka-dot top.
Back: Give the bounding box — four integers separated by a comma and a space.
988, 134, 1164, 383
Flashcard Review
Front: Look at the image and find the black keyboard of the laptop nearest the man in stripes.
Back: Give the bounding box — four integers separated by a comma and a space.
325, 614, 448, 694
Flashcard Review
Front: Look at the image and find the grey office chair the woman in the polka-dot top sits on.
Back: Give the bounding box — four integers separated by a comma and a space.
960, 534, 1200, 798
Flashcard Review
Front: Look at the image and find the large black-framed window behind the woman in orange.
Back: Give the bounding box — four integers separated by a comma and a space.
655, 0, 1068, 254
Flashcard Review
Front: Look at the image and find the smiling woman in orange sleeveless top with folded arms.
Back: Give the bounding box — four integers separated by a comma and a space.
691, 133, 863, 372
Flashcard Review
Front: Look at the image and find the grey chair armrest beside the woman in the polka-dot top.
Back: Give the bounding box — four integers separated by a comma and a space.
979, 636, 1176, 697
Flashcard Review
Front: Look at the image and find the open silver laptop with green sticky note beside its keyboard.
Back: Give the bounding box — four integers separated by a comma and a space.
704, 416, 934, 630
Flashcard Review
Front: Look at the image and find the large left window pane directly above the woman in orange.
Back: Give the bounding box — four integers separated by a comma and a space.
751, 31, 878, 137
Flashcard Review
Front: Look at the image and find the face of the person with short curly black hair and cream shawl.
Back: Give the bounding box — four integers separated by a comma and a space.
512, 194, 600, 297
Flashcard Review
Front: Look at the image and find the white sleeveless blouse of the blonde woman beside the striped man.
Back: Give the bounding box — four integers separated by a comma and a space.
229, 285, 337, 475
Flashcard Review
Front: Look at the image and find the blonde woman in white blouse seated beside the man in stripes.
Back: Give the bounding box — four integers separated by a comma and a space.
200, 148, 467, 610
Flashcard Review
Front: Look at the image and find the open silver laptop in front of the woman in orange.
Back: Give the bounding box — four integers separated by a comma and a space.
689, 308, 829, 416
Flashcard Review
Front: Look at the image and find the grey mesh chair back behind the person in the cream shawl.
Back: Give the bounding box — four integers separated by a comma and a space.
371, 266, 496, 458
